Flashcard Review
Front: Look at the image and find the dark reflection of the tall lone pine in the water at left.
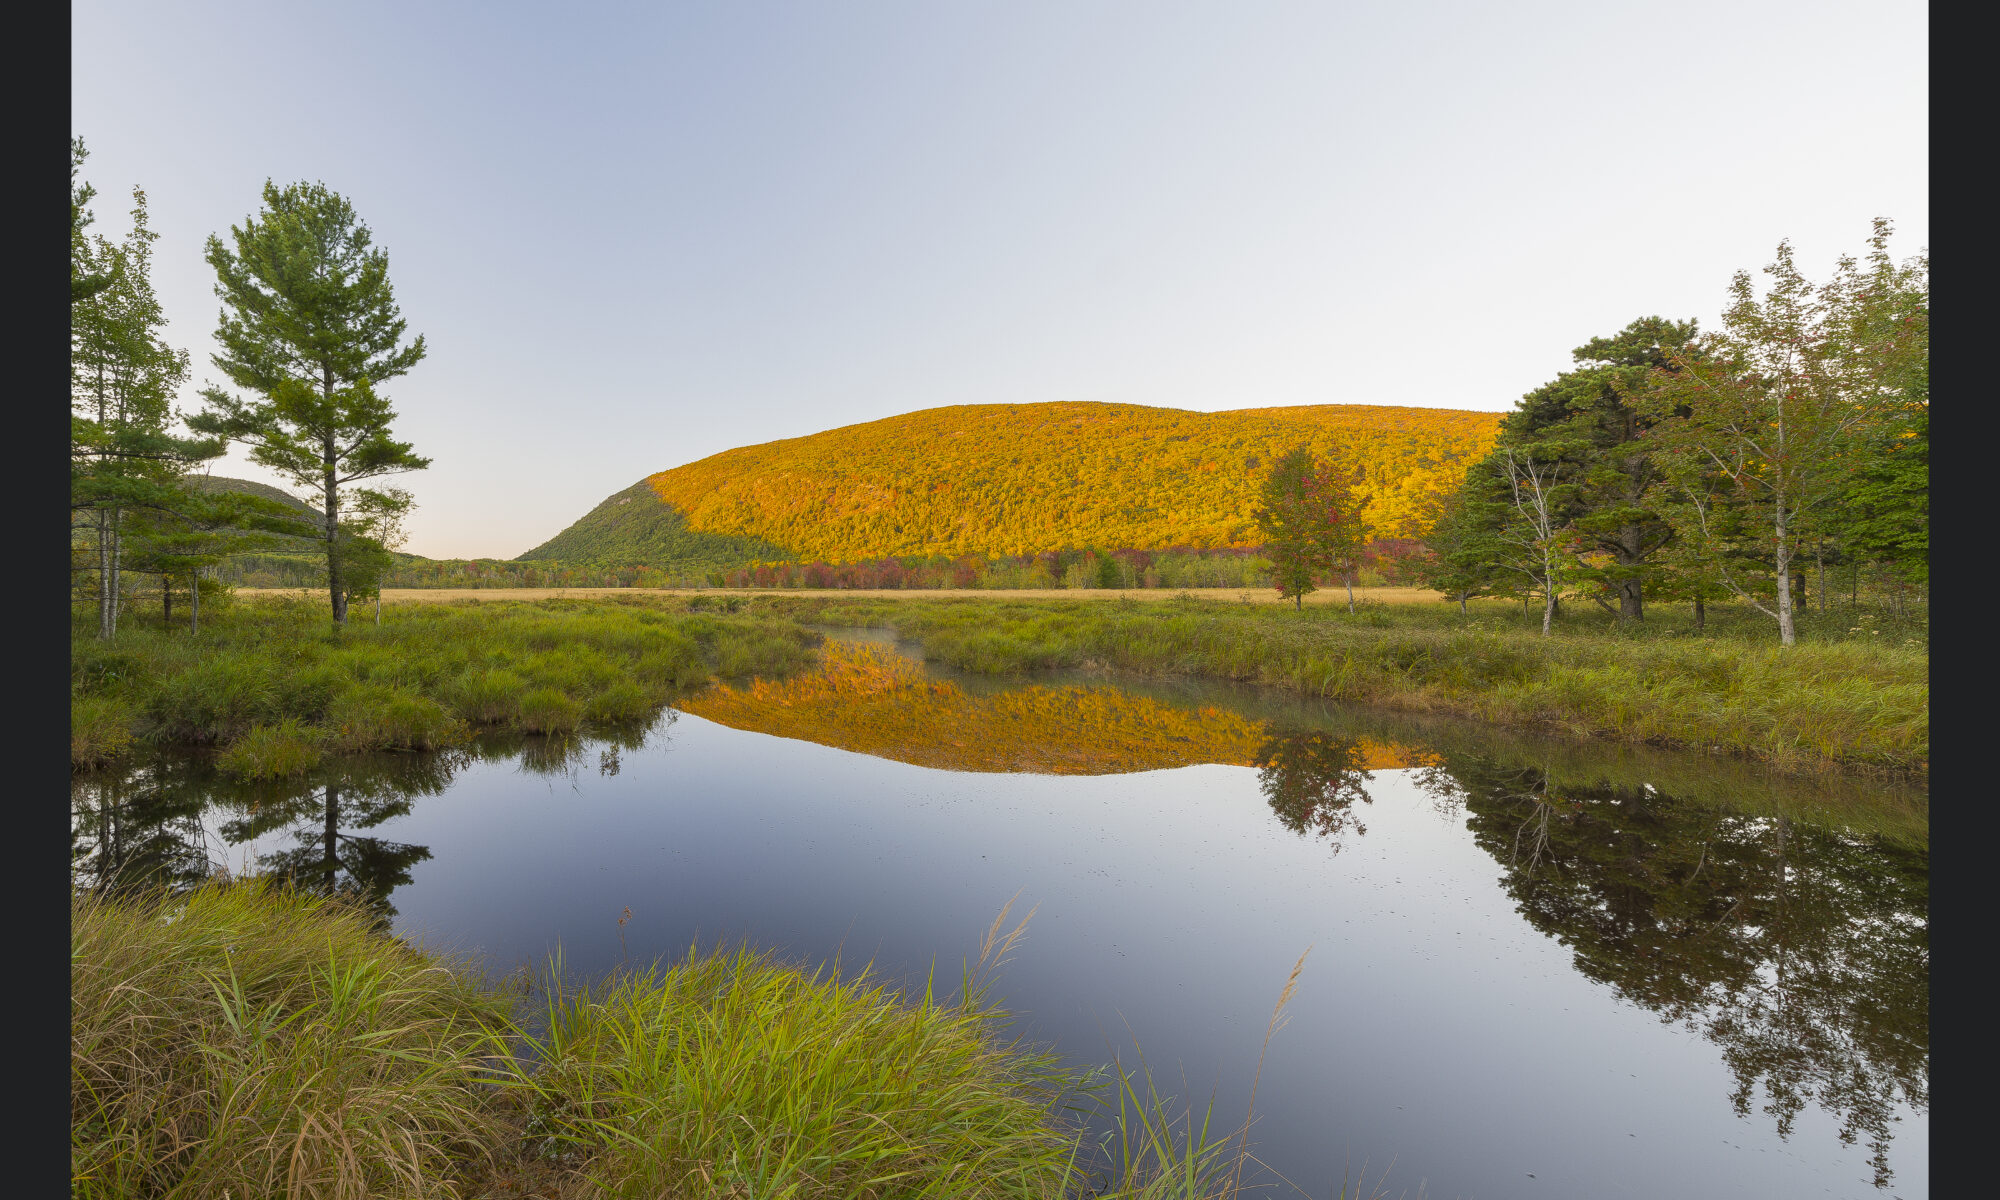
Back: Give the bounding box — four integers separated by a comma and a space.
222, 754, 462, 924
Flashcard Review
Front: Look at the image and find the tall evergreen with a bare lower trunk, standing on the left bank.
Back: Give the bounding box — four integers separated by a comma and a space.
190, 182, 430, 622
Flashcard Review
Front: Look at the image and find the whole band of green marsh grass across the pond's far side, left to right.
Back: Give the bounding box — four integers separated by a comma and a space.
70, 592, 1930, 778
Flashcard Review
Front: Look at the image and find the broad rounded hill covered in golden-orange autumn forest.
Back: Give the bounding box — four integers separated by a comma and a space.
522, 402, 1500, 566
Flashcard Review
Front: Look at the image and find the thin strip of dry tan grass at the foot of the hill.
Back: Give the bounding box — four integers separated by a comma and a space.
236, 588, 1444, 618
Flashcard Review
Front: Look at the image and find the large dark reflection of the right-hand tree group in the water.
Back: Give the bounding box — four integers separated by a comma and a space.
1420, 756, 1930, 1186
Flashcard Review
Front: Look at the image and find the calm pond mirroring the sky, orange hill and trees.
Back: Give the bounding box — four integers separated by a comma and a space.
72, 634, 1930, 1198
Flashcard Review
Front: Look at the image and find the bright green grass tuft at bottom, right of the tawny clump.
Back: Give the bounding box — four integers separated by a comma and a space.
508, 908, 1082, 1198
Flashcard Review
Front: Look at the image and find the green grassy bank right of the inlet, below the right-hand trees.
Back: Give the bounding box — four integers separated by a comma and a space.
760, 598, 1930, 772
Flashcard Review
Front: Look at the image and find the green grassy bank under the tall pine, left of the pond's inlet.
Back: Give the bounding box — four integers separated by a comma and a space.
70, 598, 816, 778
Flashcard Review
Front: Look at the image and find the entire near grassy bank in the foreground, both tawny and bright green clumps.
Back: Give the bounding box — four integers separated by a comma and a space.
70, 884, 1264, 1200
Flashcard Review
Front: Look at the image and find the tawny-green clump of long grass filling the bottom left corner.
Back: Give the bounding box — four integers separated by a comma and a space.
70, 884, 506, 1198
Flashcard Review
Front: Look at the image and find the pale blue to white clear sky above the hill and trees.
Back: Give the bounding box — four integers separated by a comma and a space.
70, 0, 1930, 558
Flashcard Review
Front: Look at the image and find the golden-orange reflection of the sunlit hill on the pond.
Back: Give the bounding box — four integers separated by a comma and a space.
678, 642, 1420, 774
